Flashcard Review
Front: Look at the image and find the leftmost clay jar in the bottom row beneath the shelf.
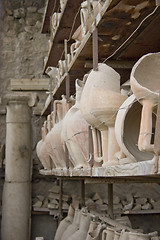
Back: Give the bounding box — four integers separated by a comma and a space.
54, 205, 75, 240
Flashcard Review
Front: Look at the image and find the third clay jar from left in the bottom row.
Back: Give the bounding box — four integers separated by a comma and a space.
68, 211, 91, 240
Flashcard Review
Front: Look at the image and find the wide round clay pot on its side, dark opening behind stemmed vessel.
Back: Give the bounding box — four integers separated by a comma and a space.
115, 94, 156, 163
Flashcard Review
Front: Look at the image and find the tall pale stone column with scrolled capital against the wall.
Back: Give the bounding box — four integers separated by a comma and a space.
1, 93, 36, 240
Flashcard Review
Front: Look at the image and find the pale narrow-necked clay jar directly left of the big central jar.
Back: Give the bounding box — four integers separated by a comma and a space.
62, 79, 89, 168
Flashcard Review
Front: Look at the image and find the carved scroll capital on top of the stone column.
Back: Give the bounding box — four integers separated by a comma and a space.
2, 92, 38, 107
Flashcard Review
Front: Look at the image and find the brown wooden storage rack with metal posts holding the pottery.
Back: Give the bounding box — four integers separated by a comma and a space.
41, 0, 160, 221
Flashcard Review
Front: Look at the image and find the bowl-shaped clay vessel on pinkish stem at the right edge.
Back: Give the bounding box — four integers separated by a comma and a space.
130, 53, 160, 152
